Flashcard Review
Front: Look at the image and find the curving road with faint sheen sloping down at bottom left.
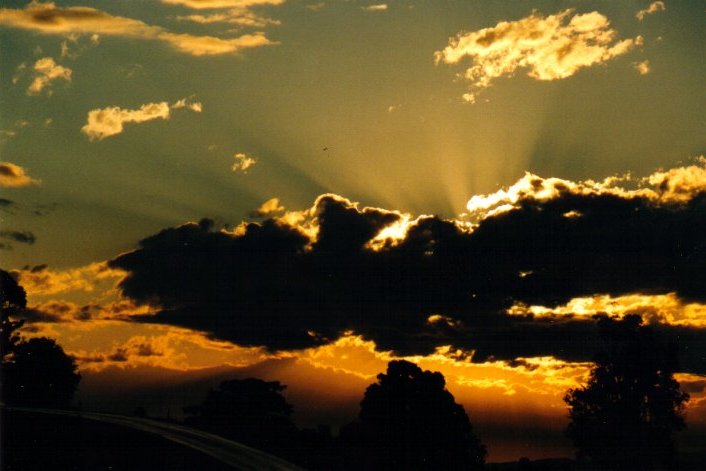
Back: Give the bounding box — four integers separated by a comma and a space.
8, 407, 304, 471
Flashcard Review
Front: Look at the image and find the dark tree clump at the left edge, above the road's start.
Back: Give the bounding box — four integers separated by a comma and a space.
0, 270, 81, 407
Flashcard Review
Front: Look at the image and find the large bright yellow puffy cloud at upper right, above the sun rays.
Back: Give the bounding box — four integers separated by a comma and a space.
435, 10, 642, 102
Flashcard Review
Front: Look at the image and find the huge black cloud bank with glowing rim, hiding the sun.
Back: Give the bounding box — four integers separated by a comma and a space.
110, 189, 706, 371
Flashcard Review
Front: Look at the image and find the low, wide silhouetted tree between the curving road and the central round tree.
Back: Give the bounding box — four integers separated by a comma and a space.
184, 378, 296, 450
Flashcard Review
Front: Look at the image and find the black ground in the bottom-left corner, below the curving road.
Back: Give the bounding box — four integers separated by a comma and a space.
0, 411, 233, 471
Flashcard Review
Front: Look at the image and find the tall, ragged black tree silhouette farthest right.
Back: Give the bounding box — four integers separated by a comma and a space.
564, 315, 689, 471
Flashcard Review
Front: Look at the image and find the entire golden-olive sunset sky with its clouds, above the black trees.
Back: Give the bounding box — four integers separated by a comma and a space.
0, 0, 706, 461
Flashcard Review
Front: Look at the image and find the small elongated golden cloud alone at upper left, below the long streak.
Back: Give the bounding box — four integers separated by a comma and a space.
81, 98, 202, 141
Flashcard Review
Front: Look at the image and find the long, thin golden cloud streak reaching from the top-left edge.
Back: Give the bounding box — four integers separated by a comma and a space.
0, 1, 272, 56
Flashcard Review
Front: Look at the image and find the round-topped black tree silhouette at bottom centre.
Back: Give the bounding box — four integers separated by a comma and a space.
341, 360, 486, 470
